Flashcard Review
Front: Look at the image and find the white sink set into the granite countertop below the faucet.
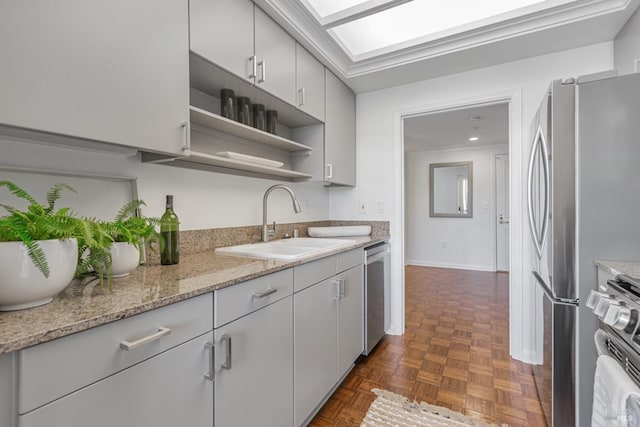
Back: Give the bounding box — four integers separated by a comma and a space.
216, 237, 355, 261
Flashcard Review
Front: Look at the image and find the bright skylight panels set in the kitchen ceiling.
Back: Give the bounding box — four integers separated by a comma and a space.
301, 0, 572, 59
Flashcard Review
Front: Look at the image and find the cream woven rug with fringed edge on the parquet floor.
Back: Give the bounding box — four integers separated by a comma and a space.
360, 388, 495, 427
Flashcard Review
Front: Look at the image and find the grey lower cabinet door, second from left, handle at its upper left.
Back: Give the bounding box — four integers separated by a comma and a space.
215, 296, 293, 427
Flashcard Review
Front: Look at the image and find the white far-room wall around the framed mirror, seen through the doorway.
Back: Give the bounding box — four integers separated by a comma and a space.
404, 145, 508, 271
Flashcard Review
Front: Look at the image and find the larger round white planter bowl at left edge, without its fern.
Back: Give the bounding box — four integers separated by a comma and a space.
0, 239, 78, 311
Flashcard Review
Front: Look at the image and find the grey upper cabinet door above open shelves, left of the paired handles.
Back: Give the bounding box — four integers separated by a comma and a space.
189, 0, 254, 83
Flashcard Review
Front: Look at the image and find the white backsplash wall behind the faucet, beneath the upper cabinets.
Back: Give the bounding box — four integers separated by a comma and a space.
0, 139, 329, 230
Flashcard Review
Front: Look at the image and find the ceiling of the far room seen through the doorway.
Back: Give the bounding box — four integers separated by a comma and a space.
403, 103, 509, 152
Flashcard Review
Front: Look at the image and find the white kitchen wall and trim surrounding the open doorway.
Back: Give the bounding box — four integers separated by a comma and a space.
330, 42, 613, 361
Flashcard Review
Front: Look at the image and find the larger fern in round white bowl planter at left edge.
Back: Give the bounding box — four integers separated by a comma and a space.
0, 181, 111, 311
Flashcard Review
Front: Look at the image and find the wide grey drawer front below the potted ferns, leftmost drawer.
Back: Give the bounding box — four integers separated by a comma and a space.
18, 293, 213, 414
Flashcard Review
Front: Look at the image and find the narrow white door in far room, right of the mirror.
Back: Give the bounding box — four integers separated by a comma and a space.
496, 154, 509, 271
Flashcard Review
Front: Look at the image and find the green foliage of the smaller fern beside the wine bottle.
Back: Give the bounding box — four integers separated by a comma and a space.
101, 200, 163, 254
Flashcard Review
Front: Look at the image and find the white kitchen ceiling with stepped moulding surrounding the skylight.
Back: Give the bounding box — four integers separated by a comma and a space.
254, 0, 640, 93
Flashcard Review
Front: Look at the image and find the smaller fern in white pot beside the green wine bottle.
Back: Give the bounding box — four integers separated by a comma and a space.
101, 200, 162, 278
